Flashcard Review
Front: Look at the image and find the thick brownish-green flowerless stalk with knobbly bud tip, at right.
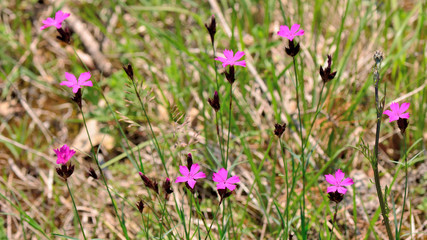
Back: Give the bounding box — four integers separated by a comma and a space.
371, 53, 394, 240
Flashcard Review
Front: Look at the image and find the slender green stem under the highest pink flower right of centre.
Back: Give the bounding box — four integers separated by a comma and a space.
292, 57, 307, 240
